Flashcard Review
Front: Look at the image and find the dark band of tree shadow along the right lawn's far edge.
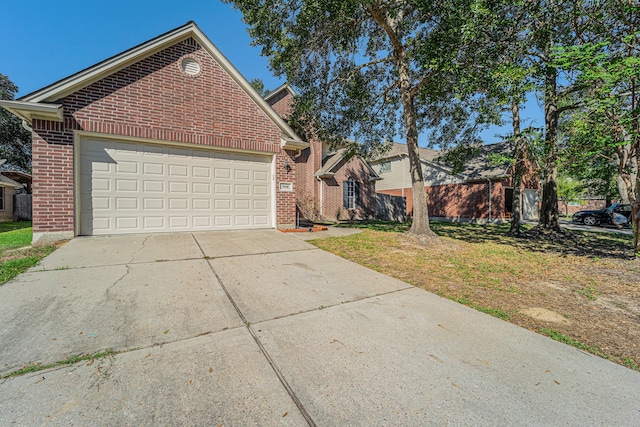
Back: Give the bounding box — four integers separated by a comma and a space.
338, 221, 636, 260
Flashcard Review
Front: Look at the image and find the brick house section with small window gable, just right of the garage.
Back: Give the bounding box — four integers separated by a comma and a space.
265, 84, 379, 220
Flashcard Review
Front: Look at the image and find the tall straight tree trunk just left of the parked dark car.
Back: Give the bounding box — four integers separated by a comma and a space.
538, 65, 561, 232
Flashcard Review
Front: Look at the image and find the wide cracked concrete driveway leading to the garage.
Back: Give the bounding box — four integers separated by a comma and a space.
0, 230, 640, 426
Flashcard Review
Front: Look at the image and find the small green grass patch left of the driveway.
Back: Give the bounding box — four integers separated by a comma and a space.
0, 221, 55, 286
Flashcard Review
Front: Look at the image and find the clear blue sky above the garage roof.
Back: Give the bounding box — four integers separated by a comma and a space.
0, 0, 538, 145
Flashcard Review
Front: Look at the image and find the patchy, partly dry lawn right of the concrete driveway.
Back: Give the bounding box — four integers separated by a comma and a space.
311, 223, 640, 370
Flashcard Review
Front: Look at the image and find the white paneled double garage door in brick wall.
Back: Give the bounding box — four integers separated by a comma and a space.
79, 138, 272, 235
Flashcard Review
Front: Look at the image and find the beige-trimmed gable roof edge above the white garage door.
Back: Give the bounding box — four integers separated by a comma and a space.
0, 21, 308, 149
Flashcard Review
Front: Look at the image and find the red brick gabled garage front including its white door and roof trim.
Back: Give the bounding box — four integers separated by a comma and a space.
0, 22, 309, 245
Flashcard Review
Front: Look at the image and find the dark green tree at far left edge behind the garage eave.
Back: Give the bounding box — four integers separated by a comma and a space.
0, 74, 31, 172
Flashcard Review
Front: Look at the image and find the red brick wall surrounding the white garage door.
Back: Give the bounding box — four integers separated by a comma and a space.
33, 39, 295, 237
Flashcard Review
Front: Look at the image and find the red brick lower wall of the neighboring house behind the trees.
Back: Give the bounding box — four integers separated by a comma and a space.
379, 181, 505, 219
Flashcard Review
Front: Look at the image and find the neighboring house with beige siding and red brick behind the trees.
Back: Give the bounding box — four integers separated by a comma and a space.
370, 142, 538, 222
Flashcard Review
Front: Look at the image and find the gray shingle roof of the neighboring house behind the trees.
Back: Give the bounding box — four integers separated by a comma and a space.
372, 141, 511, 180
